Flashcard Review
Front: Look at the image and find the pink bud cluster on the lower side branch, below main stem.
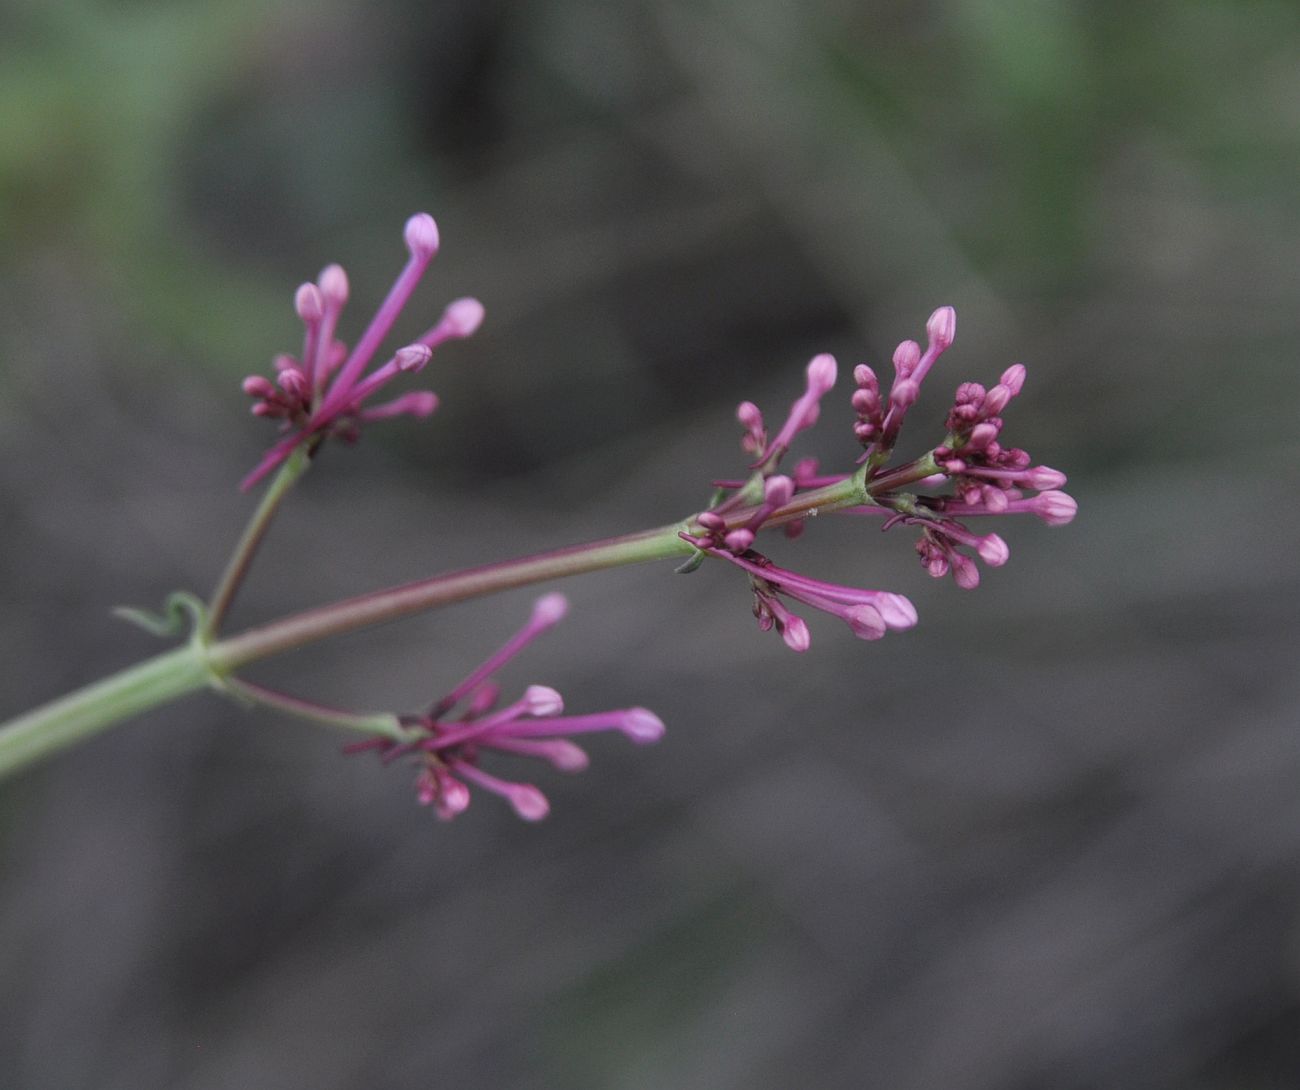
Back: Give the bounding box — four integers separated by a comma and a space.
346, 594, 664, 821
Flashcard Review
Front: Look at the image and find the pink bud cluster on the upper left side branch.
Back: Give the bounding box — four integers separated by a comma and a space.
241, 212, 484, 489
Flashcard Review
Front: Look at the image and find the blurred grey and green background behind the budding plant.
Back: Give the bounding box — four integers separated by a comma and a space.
0, 0, 1300, 1090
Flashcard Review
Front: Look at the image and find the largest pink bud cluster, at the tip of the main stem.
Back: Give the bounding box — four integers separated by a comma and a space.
681, 307, 1078, 652
